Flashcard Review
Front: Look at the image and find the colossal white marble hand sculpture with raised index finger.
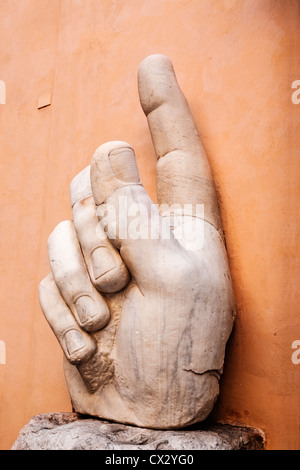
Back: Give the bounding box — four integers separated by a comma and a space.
40, 55, 235, 429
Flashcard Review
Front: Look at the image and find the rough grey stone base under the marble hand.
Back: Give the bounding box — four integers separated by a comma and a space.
12, 413, 263, 450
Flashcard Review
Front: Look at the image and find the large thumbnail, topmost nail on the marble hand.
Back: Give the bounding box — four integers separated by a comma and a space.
109, 147, 140, 183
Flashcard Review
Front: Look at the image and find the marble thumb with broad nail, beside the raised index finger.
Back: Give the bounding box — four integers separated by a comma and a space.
91, 141, 181, 292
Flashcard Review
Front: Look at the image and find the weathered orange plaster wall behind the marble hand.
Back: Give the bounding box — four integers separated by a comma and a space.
0, 0, 300, 449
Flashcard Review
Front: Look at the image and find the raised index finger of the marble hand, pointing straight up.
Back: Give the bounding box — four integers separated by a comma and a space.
138, 54, 221, 229
